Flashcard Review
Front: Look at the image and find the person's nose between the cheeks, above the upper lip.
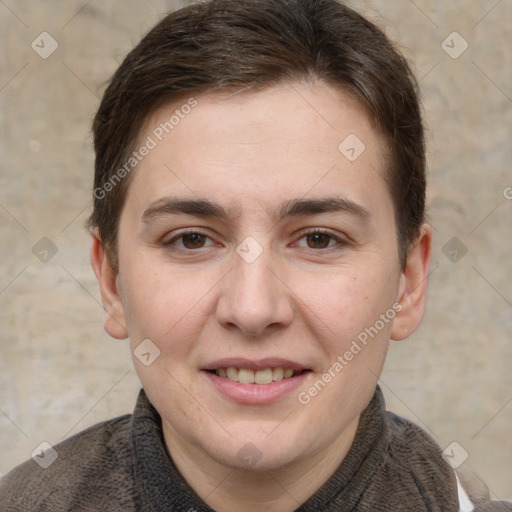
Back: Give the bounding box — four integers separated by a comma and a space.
216, 247, 294, 337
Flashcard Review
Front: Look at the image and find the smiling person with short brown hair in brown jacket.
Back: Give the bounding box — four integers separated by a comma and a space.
0, 0, 512, 512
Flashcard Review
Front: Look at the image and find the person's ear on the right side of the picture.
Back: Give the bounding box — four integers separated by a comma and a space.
391, 224, 432, 341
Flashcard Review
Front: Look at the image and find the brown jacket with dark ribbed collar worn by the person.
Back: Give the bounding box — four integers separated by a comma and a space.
0, 388, 512, 512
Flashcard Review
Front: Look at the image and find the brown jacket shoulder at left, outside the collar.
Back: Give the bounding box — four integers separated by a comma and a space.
0, 415, 137, 512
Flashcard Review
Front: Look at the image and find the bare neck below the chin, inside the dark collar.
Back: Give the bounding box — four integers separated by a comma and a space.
164, 418, 359, 512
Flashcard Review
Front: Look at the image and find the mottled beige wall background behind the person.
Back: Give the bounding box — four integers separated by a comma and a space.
0, 0, 512, 498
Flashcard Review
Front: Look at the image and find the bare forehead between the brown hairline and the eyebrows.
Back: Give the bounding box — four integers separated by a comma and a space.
127, 83, 391, 217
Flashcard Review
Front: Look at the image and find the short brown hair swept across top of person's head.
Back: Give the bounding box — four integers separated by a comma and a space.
88, 0, 426, 266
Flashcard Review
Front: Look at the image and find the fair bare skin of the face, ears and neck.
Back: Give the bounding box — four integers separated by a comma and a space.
91, 83, 432, 512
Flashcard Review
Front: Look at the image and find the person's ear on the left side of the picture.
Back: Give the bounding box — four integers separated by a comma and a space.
91, 230, 128, 340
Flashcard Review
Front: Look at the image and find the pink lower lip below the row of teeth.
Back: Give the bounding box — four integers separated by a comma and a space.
202, 371, 311, 405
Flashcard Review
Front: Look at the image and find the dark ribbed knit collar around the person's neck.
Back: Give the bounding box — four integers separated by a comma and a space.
130, 387, 390, 512
